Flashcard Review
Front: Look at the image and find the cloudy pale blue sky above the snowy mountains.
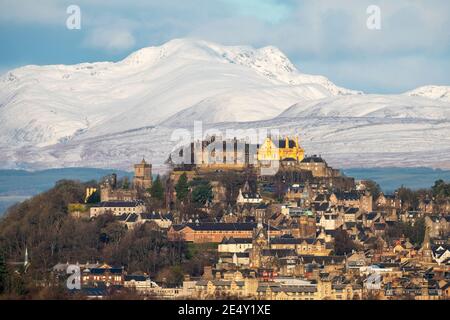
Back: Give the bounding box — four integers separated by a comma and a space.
0, 0, 450, 93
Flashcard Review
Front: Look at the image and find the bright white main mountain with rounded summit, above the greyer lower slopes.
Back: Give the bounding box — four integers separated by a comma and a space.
0, 39, 356, 146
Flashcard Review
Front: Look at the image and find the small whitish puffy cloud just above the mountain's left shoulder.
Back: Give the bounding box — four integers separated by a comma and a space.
84, 28, 136, 52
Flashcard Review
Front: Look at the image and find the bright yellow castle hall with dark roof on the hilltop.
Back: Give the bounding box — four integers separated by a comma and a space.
258, 137, 305, 162
